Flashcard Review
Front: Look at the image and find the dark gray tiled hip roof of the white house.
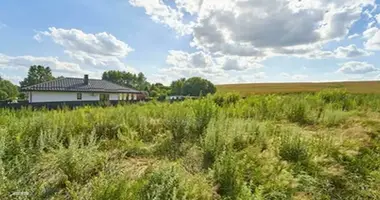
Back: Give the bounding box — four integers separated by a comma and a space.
22, 78, 140, 93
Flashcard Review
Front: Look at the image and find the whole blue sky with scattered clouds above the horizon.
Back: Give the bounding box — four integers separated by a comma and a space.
0, 0, 380, 84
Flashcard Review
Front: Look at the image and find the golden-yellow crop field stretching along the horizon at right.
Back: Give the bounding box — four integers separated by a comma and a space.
217, 81, 380, 96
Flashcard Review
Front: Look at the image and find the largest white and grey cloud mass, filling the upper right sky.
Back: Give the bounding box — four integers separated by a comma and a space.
129, 0, 376, 72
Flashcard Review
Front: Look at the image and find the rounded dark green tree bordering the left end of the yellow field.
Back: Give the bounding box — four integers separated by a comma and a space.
183, 77, 216, 96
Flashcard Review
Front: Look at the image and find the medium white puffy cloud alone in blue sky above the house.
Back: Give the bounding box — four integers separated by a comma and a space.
34, 27, 136, 72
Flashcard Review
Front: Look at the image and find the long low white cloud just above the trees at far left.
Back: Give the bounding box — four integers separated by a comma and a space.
0, 54, 88, 75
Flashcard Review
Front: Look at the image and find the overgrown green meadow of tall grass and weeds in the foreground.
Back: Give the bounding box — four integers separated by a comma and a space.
0, 89, 380, 200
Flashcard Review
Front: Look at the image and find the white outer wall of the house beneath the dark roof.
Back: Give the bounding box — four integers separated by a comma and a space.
29, 92, 99, 103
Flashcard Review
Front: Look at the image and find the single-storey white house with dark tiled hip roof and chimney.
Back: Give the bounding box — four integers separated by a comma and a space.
22, 75, 145, 103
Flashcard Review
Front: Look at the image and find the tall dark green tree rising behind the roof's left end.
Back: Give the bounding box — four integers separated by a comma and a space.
20, 65, 54, 87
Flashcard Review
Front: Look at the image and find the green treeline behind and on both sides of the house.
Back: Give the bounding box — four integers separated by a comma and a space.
0, 65, 216, 100
